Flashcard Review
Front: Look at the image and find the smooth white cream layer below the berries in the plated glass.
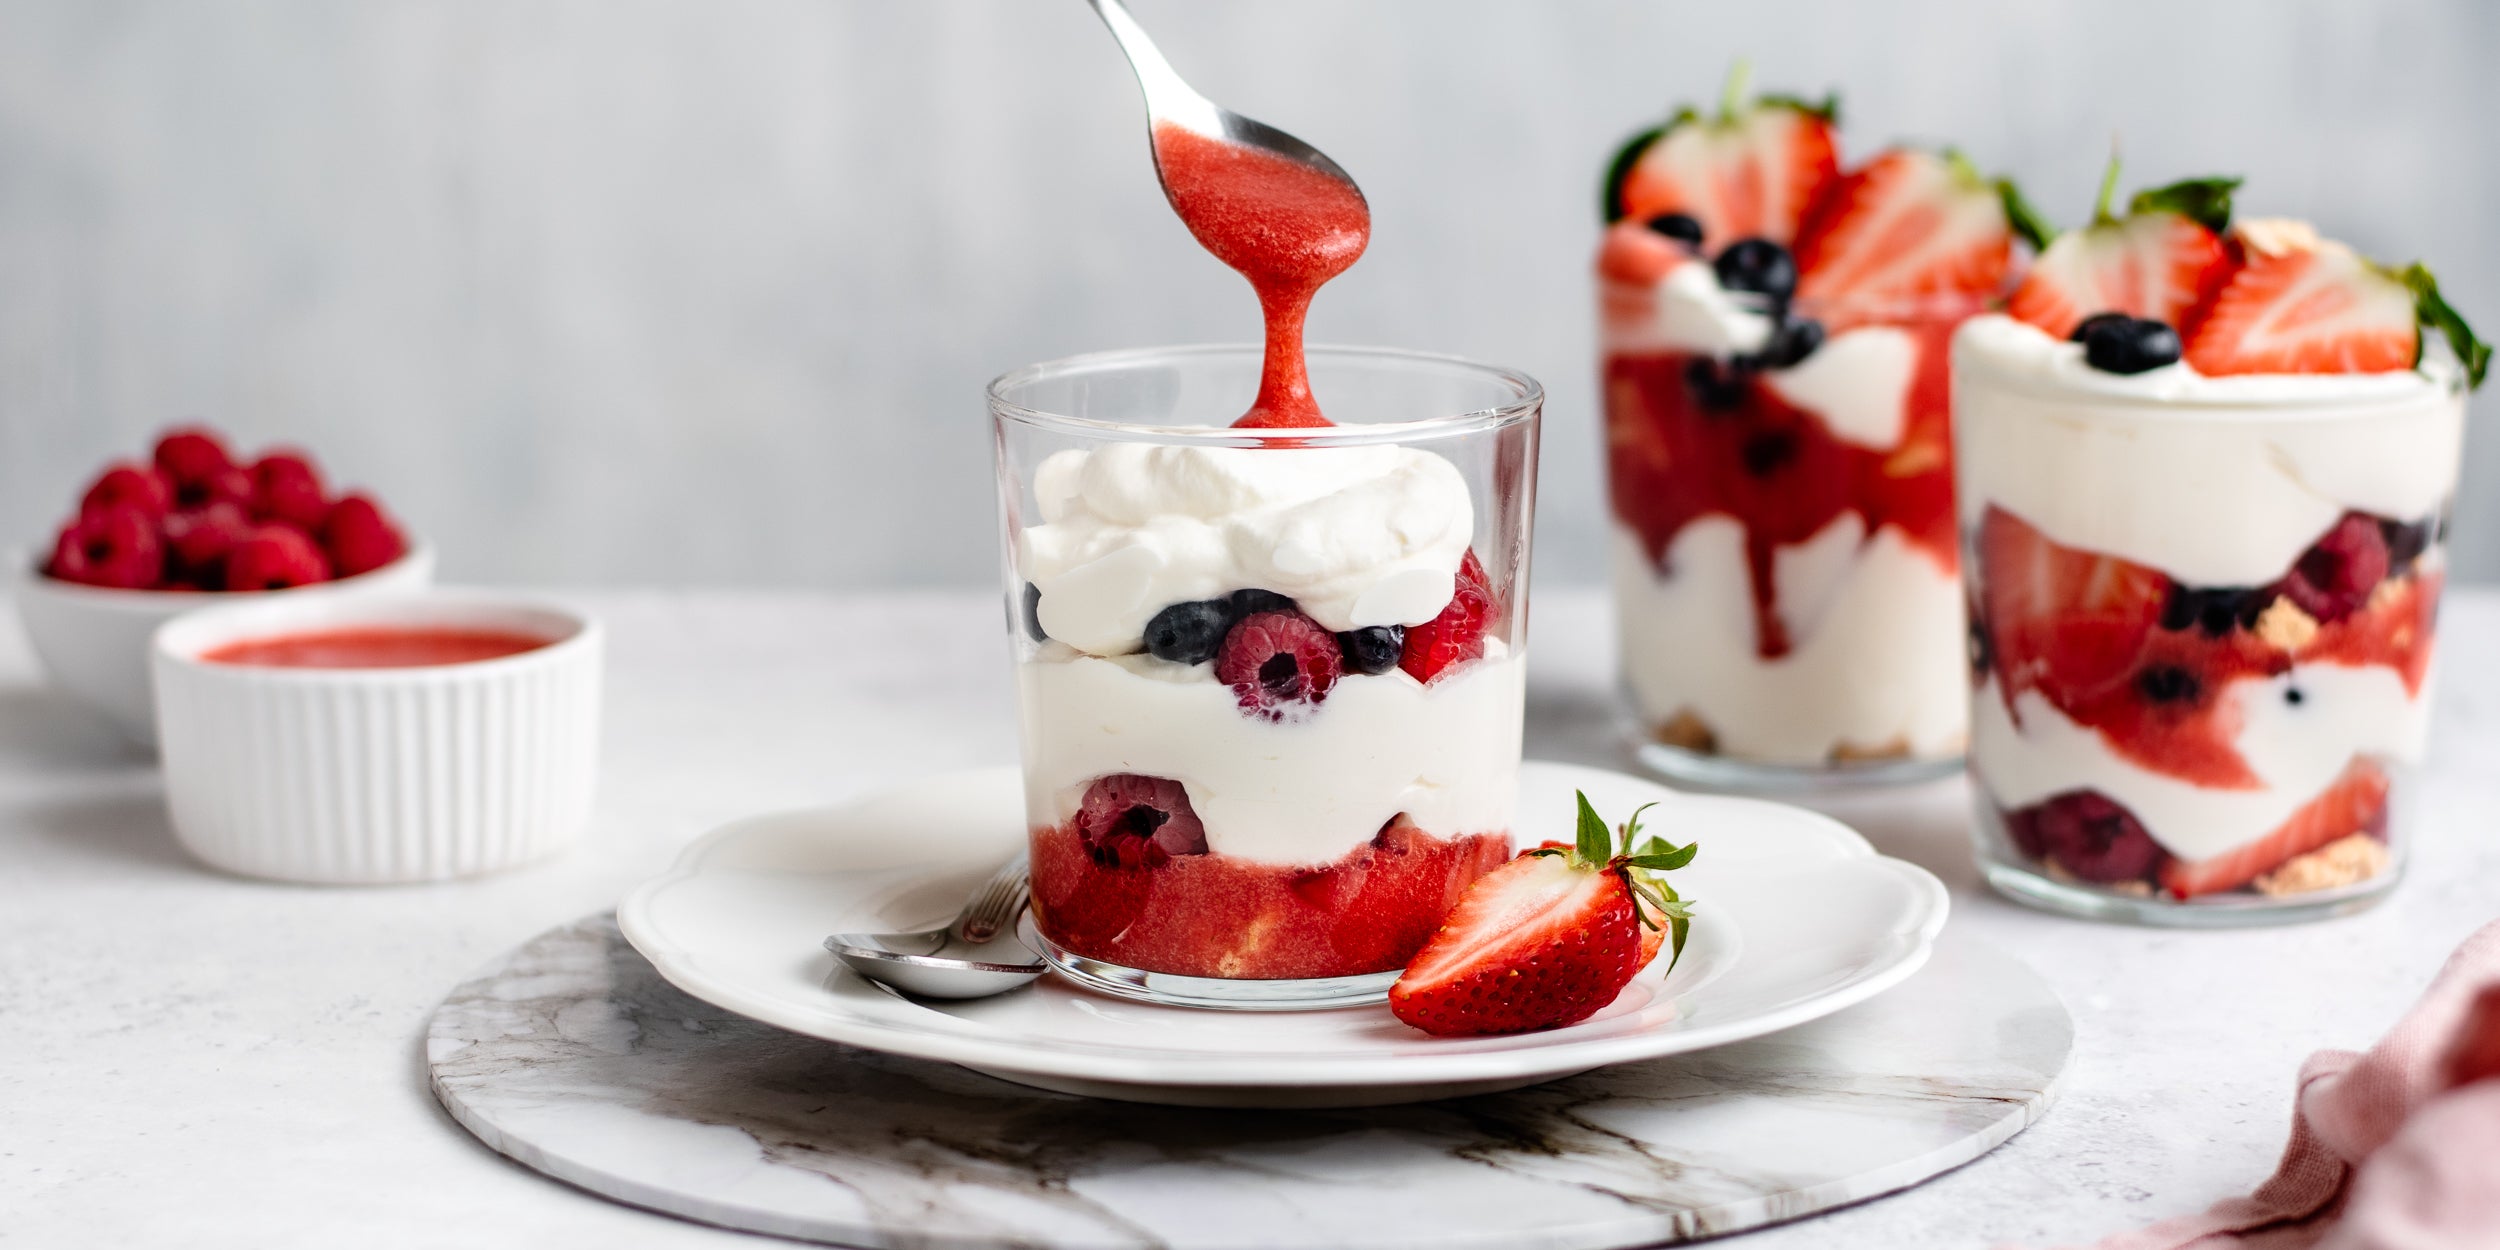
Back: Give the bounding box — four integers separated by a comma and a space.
1015, 638, 1528, 865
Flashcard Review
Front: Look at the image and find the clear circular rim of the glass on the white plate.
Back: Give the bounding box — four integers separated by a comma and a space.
983, 343, 1545, 448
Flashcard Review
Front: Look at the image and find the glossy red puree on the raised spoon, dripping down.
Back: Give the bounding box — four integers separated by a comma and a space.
1155, 123, 1373, 428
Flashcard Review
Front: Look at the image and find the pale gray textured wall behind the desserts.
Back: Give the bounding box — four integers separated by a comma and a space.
0, 0, 2500, 585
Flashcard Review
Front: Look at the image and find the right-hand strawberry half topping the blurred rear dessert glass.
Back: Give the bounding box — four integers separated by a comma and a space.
1795, 148, 2015, 300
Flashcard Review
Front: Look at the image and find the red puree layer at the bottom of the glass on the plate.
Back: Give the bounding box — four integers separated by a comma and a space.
1033, 818, 1510, 980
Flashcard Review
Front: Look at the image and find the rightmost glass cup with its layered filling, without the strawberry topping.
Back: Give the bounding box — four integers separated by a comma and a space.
1955, 318, 2465, 928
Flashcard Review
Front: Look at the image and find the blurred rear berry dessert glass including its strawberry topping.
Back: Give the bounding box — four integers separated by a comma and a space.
1598, 75, 2023, 788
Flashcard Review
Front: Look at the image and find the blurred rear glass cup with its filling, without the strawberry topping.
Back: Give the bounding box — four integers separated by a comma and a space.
1600, 283, 1980, 790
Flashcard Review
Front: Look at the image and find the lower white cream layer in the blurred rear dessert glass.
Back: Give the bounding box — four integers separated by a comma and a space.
1615, 513, 1970, 765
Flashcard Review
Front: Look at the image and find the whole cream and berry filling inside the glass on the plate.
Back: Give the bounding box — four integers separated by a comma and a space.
1015, 443, 1525, 980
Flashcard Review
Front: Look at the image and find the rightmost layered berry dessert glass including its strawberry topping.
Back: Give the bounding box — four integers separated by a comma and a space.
1953, 170, 2490, 925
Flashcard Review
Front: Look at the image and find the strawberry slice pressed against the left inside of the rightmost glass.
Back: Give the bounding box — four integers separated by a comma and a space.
1980, 508, 2170, 708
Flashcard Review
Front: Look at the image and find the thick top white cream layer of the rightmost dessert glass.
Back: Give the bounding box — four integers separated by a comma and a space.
1953, 315, 2465, 585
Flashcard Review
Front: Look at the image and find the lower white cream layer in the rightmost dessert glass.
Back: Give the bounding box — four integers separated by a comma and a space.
1970, 665, 2430, 860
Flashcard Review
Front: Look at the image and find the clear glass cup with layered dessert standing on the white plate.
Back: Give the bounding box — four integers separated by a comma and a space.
990, 345, 1543, 1010
